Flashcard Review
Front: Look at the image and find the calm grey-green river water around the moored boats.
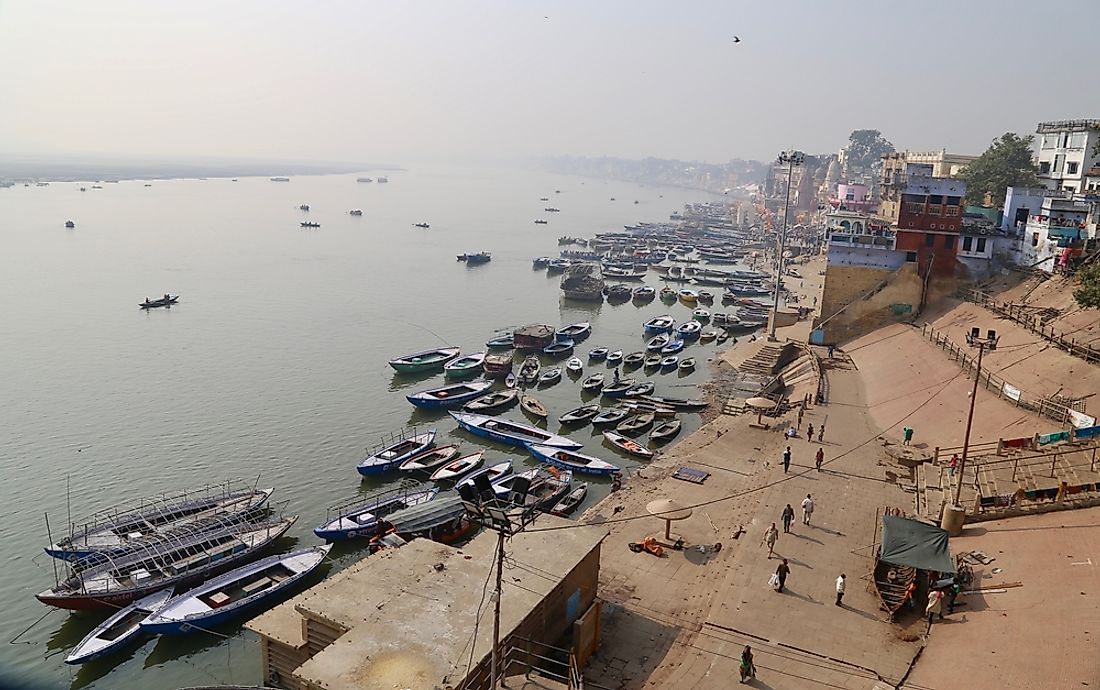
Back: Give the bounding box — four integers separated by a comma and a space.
0, 168, 739, 688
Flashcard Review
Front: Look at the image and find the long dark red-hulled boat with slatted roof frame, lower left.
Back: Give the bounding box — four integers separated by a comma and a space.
35, 515, 298, 611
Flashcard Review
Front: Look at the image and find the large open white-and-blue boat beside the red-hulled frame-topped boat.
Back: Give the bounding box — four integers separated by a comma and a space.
141, 544, 332, 635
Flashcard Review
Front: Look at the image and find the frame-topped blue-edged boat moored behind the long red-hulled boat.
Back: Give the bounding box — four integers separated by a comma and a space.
45, 483, 275, 561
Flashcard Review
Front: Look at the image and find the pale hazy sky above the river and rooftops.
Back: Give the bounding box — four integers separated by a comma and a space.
0, 0, 1100, 164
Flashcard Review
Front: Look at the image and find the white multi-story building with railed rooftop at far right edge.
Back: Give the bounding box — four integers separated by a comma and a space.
1035, 120, 1100, 191
